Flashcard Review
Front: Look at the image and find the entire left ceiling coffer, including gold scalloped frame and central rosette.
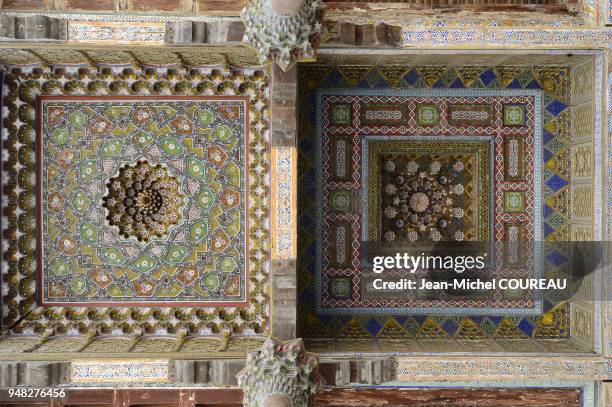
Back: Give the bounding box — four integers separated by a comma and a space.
2, 70, 270, 336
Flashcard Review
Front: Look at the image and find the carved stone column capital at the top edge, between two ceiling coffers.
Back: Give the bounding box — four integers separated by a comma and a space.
242, 0, 323, 71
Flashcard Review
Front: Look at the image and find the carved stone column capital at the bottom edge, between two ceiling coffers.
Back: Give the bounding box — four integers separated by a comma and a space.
238, 338, 325, 407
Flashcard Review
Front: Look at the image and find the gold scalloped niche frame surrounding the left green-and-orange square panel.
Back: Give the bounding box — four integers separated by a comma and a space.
3, 68, 270, 340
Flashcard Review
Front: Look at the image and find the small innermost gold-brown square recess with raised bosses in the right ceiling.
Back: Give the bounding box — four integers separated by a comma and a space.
362, 136, 493, 242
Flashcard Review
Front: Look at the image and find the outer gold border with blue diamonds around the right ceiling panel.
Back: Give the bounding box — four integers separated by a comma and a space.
298, 65, 570, 339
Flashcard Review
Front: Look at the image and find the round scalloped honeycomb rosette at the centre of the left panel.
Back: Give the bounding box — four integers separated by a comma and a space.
102, 161, 184, 242
